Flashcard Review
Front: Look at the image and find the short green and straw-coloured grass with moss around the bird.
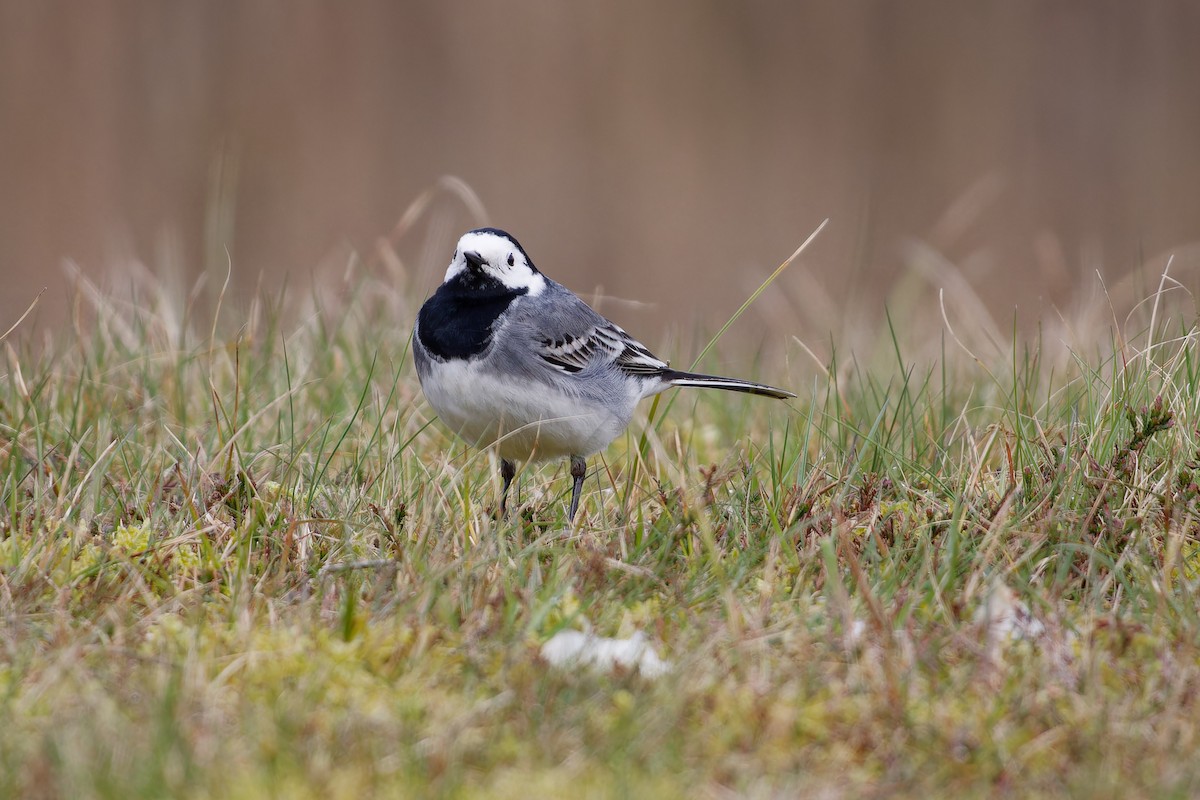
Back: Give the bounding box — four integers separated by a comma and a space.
0, 245, 1200, 798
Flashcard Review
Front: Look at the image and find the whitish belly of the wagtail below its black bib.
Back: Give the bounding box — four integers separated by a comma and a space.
421, 361, 637, 461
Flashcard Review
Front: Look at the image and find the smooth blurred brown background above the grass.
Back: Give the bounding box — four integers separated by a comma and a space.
0, 0, 1200, 350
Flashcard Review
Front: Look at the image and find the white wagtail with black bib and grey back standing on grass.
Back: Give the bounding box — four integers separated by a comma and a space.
413, 228, 796, 521
